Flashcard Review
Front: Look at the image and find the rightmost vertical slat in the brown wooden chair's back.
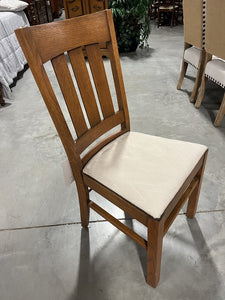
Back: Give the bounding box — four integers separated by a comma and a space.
86, 44, 114, 118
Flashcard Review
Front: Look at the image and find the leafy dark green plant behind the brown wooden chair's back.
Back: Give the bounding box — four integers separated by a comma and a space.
109, 0, 151, 52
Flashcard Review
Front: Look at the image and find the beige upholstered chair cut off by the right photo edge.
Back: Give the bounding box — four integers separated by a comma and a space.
195, 0, 225, 126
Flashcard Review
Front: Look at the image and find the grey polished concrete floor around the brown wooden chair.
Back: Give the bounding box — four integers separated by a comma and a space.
0, 19, 225, 300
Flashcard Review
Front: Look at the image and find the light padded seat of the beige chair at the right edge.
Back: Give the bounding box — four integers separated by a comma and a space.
205, 59, 225, 88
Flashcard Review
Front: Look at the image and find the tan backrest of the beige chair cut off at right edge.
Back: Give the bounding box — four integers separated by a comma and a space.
205, 0, 225, 59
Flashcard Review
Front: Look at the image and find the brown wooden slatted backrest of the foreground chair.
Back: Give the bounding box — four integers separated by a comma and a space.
16, 10, 130, 181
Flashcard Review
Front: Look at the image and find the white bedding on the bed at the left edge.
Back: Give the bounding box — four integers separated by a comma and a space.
0, 11, 29, 99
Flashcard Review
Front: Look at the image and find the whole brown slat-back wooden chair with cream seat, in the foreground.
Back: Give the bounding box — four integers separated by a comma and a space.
16, 10, 207, 287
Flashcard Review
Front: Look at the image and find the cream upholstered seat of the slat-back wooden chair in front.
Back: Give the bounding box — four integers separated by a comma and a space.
83, 132, 207, 218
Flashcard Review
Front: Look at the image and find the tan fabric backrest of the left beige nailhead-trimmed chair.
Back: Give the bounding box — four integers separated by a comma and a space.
183, 0, 205, 49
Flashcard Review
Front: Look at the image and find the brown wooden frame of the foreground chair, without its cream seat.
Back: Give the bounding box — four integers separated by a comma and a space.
16, 10, 205, 287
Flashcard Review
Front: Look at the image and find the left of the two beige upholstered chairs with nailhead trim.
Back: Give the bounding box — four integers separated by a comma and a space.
177, 0, 205, 102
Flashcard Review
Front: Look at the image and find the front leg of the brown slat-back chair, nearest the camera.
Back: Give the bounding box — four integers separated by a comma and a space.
147, 217, 164, 288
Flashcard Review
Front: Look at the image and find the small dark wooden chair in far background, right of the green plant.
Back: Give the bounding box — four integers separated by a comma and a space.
157, 0, 179, 27
